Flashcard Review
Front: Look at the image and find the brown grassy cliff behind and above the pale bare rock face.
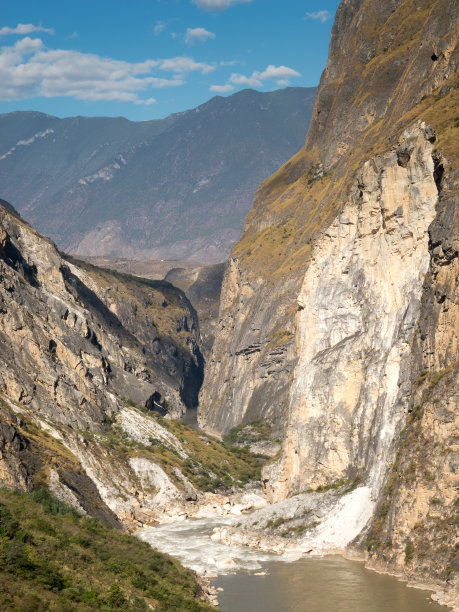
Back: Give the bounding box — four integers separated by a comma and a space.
201, 0, 457, 430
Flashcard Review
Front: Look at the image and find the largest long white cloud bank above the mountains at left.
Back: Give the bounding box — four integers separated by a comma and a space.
0, 36, 215, 104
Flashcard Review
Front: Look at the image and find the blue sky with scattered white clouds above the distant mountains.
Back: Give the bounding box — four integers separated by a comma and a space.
0, 0, 339, 121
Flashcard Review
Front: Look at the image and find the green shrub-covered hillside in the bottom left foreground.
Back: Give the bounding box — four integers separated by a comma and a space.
0, 489, 215, 612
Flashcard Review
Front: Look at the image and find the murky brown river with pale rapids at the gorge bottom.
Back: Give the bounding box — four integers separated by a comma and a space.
137, 517, 446, 612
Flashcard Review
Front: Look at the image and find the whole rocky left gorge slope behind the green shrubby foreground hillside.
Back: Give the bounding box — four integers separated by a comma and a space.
0, 206, 260, 527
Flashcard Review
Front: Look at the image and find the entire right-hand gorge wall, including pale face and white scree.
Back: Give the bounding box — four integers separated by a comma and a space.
200, 0, 459, 596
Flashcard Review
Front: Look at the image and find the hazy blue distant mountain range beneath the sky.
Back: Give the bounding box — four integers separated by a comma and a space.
0, 87, 316, 262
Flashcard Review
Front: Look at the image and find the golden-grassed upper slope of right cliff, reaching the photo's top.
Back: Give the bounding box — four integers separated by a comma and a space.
232, 0, 459, 282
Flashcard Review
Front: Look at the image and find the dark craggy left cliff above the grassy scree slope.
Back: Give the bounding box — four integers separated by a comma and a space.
0, 208, 202, 429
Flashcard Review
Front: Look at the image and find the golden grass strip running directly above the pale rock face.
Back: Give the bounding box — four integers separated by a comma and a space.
232, 73, 459, 280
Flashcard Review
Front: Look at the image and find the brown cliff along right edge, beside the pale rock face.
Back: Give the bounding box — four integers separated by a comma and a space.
365, 157, 459, 583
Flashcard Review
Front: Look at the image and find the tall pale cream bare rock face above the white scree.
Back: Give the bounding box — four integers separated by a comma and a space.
265, 126, 438, 500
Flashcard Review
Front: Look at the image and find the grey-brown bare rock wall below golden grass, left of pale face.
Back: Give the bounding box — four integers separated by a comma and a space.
199, 258, 295, 433
